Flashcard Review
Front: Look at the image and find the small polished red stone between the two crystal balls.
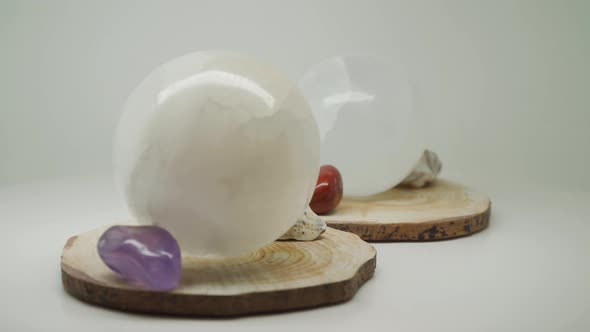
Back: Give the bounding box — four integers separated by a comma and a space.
309, 165, 342, 214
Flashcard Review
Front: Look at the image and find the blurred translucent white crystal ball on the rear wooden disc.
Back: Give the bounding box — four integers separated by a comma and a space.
299, 56, 425, 197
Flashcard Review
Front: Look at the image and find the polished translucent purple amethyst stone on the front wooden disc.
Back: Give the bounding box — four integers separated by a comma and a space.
98, 226, 182, 291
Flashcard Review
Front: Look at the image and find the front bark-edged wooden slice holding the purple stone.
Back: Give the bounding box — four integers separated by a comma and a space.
61, 226, 376, 316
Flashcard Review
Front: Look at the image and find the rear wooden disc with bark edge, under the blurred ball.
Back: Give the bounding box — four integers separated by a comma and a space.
322, 180, 491, 241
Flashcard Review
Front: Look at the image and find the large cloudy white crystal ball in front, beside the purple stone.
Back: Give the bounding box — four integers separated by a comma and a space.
114, 51, 320, 256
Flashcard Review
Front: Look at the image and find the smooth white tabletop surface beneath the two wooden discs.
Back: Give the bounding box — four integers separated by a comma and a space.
0, 177, 590, 332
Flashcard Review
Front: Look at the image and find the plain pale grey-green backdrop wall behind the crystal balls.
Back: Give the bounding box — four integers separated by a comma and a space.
0, 0, 590, 192
